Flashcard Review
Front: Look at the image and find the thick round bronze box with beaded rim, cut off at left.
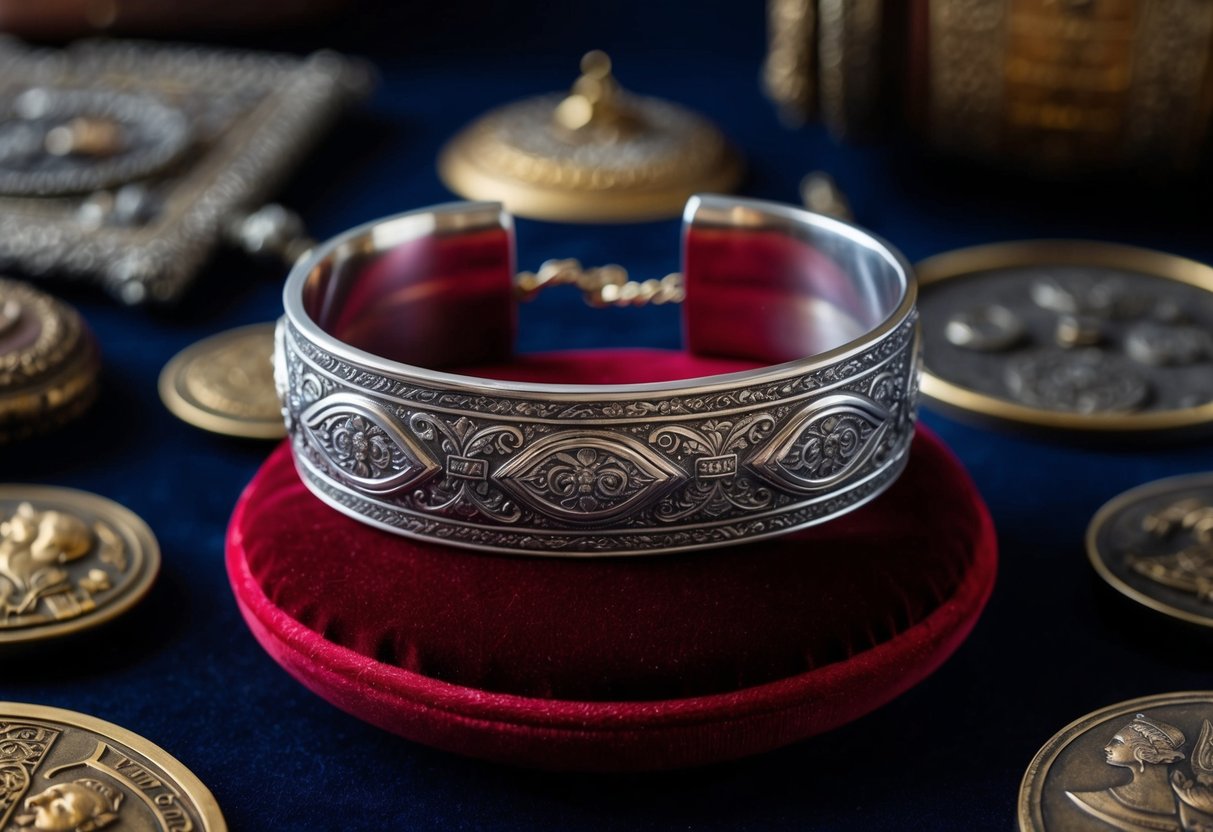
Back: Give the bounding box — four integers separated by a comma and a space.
0, 278, 101, 443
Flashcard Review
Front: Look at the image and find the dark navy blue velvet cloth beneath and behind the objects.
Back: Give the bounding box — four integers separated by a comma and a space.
7, 0, 1213, 831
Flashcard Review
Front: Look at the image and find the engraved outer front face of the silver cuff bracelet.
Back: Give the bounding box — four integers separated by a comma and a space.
277, 309, 916, 553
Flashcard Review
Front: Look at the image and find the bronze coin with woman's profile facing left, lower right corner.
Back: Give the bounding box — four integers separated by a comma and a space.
1019, 691, 1213, 832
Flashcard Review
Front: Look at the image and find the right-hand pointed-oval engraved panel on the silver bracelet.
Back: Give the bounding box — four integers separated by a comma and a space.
748, 393, 892, 494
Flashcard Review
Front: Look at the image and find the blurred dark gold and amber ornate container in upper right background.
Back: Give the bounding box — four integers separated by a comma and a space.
765, 0, 1213, 172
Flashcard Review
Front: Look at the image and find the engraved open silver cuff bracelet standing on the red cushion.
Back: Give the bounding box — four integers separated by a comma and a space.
274, 196, 918, 555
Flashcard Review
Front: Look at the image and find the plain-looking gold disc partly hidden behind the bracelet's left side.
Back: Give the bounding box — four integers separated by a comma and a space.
160, 324, 286, 439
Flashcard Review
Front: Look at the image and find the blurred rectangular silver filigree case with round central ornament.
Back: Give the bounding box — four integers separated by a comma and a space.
0, 39, 370, 303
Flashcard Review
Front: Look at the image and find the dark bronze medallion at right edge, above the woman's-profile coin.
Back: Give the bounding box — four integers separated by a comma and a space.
1087, 473, 1213, 627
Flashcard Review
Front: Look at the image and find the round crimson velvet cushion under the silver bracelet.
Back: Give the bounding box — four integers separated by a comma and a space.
228, 351, 996, 770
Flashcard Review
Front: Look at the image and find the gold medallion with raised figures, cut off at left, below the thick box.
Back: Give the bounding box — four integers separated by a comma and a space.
0, 485, 160, 645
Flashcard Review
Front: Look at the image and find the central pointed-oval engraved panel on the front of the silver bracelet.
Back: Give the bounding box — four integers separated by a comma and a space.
494, 431, 687, 523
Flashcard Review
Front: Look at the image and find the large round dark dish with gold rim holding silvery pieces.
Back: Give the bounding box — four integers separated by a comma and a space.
917, 240, 1213, 435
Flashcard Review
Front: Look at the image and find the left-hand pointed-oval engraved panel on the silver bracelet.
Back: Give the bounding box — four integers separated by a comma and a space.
301, 393, 442, 494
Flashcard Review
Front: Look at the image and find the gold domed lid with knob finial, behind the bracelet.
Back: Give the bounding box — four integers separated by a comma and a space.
438, 51, 742, 222
